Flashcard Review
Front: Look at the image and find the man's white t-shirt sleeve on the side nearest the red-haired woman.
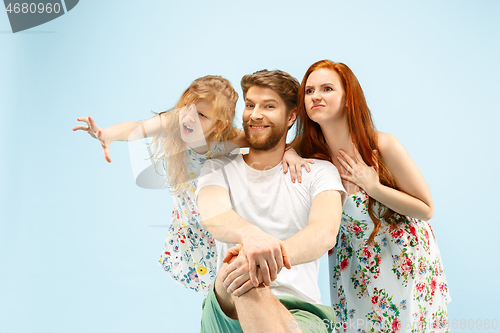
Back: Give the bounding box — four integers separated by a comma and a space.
311, 160, 347, 205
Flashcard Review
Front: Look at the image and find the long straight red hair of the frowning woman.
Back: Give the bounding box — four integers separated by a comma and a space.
292, 60, 402, 244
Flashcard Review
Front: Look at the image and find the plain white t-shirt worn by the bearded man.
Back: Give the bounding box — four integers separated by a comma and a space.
196, 155, 346, 304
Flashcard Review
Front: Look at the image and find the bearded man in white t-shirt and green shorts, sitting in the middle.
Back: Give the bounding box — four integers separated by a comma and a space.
197, 70, 345, 333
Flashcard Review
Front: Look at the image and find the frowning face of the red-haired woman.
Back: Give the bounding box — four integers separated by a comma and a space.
304, 68, 346, 124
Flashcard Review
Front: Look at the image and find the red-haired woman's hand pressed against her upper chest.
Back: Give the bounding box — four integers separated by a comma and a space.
337, 144, 380, 193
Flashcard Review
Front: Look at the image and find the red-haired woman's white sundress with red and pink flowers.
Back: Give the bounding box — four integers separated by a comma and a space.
328, 192, 451, 333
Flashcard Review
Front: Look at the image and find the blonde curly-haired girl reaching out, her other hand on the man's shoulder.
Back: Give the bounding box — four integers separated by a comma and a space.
73, 76, 308, 295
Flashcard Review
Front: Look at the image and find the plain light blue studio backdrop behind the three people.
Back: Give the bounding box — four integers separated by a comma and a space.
0, 0, 500, 333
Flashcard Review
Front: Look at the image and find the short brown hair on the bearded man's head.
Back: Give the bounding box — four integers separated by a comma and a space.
241, 69, 300, 112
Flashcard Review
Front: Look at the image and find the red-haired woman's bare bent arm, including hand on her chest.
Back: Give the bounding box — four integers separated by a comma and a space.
339, 132, 434, 221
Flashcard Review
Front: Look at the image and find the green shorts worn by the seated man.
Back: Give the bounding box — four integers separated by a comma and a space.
200, 283, 335, 333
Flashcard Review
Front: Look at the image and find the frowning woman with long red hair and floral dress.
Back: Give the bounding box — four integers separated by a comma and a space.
295, 60, 451, 332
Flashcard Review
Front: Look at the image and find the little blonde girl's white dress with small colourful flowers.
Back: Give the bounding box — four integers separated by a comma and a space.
160, 143, 225, 295
